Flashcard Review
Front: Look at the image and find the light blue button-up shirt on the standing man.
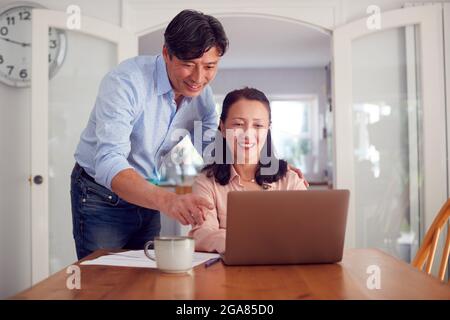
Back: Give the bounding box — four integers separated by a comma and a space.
75, 55, 218, 189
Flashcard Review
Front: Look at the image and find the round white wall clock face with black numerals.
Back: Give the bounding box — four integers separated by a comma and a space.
0, 5, 67, 87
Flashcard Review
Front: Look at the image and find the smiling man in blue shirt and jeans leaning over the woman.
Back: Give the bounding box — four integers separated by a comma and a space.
71, 10, 306, 259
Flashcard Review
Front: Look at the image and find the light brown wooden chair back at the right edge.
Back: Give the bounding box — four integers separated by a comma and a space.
412, 199, 450, 281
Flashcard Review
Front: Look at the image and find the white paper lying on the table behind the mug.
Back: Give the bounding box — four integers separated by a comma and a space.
81, 250, 219, 269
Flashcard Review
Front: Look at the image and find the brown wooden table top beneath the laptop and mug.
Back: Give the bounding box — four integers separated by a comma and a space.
13, 249, 450, 299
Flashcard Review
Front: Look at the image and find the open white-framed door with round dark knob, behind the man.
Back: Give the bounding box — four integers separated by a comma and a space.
31, 9, 138, 283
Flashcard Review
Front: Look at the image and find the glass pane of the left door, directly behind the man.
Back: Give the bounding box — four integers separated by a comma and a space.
48, 30, 117, 273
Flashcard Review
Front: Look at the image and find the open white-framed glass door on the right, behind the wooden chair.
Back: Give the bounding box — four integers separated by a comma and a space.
333, 5, 448, 261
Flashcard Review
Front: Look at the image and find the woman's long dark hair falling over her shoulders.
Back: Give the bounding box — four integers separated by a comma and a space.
202, 87, 287, 185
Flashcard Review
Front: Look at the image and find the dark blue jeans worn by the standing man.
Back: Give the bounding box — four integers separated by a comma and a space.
70, 164, 161, 259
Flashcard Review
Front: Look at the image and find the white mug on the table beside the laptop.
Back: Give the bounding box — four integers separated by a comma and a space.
144, 237, 195, 273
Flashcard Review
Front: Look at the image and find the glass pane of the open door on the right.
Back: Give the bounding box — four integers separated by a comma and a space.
352, 27, 423, 262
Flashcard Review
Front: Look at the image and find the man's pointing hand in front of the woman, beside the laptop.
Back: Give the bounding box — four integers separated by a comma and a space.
163, 193, 214, 226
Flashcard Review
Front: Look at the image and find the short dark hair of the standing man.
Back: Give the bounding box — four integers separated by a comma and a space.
164, 10, 228, 60
